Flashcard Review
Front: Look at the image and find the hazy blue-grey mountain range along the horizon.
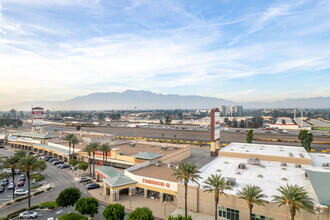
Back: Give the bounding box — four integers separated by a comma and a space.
1, 90, 330, 110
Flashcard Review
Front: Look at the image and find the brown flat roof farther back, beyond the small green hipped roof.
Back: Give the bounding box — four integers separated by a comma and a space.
113, 143, 180, 156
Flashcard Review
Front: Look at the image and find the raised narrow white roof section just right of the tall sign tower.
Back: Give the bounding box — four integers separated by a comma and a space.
220, 143, 311, 159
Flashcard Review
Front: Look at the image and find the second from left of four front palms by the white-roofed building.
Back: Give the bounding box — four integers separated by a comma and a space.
203, 174, 232, 220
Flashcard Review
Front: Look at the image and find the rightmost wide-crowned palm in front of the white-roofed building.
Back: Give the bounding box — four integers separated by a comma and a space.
273, 184, 315, 220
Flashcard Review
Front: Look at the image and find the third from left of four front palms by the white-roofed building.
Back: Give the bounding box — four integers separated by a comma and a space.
237, 185, 268, 219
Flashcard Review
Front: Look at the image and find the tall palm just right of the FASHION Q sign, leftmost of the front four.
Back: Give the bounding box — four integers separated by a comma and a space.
172, 162, 201, 218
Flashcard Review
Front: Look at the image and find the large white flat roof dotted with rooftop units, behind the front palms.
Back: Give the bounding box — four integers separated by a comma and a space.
189, 157, 318, 204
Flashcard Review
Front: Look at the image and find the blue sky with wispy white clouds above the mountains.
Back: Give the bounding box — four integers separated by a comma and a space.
0, 0, 330, 105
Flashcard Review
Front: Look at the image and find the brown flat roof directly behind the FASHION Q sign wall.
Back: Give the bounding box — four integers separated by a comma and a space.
131, 163, 178, 182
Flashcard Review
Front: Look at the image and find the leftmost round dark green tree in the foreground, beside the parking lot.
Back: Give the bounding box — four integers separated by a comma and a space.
56, 187, 81, 212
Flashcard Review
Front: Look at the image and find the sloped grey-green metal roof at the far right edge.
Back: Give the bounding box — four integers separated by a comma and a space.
305, 170, 330, 206
